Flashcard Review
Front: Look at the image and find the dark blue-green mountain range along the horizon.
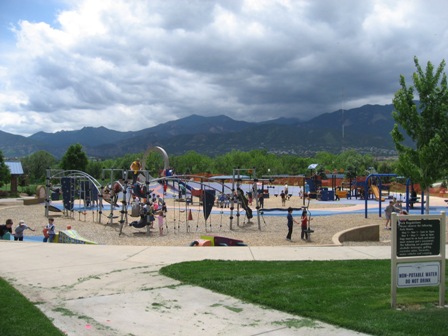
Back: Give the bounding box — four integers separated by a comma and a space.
0, 105, 395, 159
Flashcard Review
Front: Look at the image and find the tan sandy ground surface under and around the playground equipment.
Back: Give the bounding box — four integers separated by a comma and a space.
0, 192, 426, 246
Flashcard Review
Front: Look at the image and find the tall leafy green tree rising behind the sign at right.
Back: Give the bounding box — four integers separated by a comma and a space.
391, 57, 448, 213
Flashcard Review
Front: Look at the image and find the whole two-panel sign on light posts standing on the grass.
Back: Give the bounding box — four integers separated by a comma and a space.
391, 212, 446, 308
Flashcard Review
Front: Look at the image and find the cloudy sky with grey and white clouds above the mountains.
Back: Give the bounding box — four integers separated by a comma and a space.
0, 0, 448, 136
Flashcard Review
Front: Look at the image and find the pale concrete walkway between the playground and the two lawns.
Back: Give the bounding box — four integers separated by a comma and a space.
0, 242, 390, 336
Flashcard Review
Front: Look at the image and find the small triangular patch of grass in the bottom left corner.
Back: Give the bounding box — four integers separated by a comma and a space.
0, 278, 64, 336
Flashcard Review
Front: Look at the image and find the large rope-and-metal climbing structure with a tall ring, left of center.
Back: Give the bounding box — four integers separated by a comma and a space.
45, 147, 272, 235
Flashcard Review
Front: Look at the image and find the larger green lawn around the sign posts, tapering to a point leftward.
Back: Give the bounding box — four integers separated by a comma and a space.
161, 260, 448, 335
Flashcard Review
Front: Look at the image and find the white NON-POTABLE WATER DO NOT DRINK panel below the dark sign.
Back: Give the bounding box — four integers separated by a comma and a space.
397, 262, 440, 288
